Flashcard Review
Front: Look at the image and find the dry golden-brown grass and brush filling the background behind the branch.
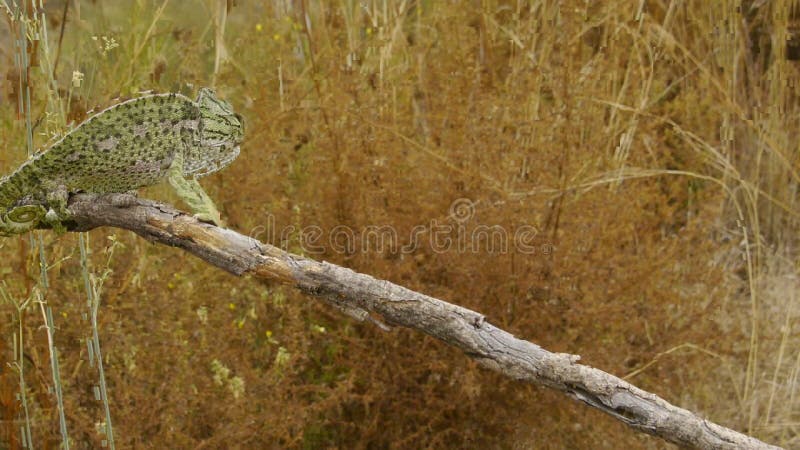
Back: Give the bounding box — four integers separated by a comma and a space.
0, 0, 800, 449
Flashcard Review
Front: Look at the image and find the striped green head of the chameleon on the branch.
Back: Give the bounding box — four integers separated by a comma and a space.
185, 88, 244, 176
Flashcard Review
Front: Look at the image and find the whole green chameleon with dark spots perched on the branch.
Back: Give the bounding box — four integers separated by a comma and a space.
0, 88, 244, 236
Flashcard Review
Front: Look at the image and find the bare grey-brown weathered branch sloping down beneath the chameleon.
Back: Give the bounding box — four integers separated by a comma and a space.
57, 194, 778, 449
